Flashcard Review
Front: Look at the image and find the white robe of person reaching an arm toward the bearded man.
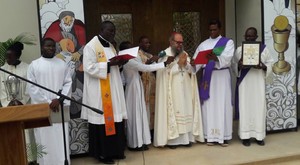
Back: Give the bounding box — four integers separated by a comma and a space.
123, 56, 165, 148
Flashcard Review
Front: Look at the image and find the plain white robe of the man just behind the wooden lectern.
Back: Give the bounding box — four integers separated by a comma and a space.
27, 57, 72, 165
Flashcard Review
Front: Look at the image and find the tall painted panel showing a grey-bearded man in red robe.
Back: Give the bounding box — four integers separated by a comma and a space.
37, 0, 88, 154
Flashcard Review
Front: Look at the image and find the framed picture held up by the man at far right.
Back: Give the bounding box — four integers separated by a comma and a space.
242, 42, 261, 66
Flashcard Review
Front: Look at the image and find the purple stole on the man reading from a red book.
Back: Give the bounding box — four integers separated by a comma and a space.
200, 37, 229, 103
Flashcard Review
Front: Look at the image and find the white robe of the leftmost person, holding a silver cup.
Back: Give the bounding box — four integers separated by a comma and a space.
0, 61, 30, 107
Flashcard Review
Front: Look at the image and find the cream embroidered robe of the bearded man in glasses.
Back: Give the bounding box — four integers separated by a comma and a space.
153, 47, 204, 147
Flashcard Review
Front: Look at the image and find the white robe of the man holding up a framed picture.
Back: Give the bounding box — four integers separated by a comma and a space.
233, 47, 273, 140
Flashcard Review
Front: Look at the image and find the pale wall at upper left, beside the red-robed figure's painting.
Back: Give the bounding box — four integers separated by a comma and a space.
0, 0, 40, 63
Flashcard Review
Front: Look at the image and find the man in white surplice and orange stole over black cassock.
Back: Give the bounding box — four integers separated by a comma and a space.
81, 21, 127, 164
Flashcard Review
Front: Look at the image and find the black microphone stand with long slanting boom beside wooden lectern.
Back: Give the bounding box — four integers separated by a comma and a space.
0, 67, 103, 165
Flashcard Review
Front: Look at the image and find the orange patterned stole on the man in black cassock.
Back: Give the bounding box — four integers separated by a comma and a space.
95, 38, 116, 136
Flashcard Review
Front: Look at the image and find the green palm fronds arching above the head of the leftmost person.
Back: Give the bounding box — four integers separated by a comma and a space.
0, 32, 36, 66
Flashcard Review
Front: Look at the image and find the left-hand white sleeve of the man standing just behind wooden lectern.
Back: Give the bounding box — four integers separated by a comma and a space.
27, 64, 52, 104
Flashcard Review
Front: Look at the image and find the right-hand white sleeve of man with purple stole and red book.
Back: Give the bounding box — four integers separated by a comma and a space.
215, 40, 234, 69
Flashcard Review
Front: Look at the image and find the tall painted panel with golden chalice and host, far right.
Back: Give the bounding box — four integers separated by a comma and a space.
263, 0, 297, 132
